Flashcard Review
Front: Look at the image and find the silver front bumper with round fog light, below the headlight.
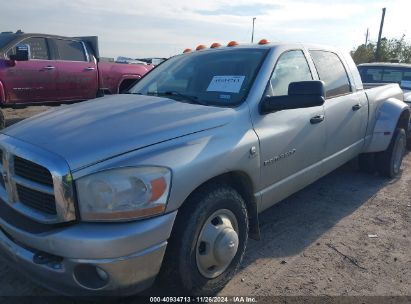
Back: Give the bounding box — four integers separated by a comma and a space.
0, 212, 176, 296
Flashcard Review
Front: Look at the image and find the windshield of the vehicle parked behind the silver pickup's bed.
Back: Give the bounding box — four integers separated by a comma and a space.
358, 66, 411, 90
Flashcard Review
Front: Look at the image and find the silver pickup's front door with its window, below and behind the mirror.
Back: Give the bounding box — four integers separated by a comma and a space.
254, 50, 325, 209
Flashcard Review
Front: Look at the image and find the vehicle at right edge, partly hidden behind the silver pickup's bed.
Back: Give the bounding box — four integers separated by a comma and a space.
358, 62, 411, 144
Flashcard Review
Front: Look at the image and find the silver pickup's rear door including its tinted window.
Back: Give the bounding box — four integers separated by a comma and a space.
310, 50, 368, 172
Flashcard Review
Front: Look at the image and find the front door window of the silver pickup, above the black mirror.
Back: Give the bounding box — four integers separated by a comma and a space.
266, 50, 313, 96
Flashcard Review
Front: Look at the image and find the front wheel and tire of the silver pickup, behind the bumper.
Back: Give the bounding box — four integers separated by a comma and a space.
164, 185, 249, 296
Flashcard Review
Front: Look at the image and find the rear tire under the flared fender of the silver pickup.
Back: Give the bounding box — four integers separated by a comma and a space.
377, 128, 407, 178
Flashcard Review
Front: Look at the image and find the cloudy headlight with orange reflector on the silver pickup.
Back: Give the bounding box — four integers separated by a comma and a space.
76, 167, 171, 221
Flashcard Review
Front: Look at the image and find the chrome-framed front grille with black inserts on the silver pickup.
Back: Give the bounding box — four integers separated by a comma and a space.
0, 134, 75, 224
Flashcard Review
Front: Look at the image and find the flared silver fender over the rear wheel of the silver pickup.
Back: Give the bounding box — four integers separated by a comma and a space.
364, 98, 410, 153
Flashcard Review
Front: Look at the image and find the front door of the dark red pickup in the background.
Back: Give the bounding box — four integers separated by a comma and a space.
2, 37, 56, 103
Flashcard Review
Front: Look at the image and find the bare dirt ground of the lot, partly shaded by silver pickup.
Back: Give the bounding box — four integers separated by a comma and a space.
0, 105, 411, 303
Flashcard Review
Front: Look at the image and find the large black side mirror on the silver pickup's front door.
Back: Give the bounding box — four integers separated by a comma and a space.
261, 80, 325, 114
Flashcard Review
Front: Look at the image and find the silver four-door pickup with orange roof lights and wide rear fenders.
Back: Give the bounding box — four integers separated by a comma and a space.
0, 41, 410, 295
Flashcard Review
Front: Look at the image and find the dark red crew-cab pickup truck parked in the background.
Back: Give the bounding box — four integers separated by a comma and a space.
0, 32, 153, 105
